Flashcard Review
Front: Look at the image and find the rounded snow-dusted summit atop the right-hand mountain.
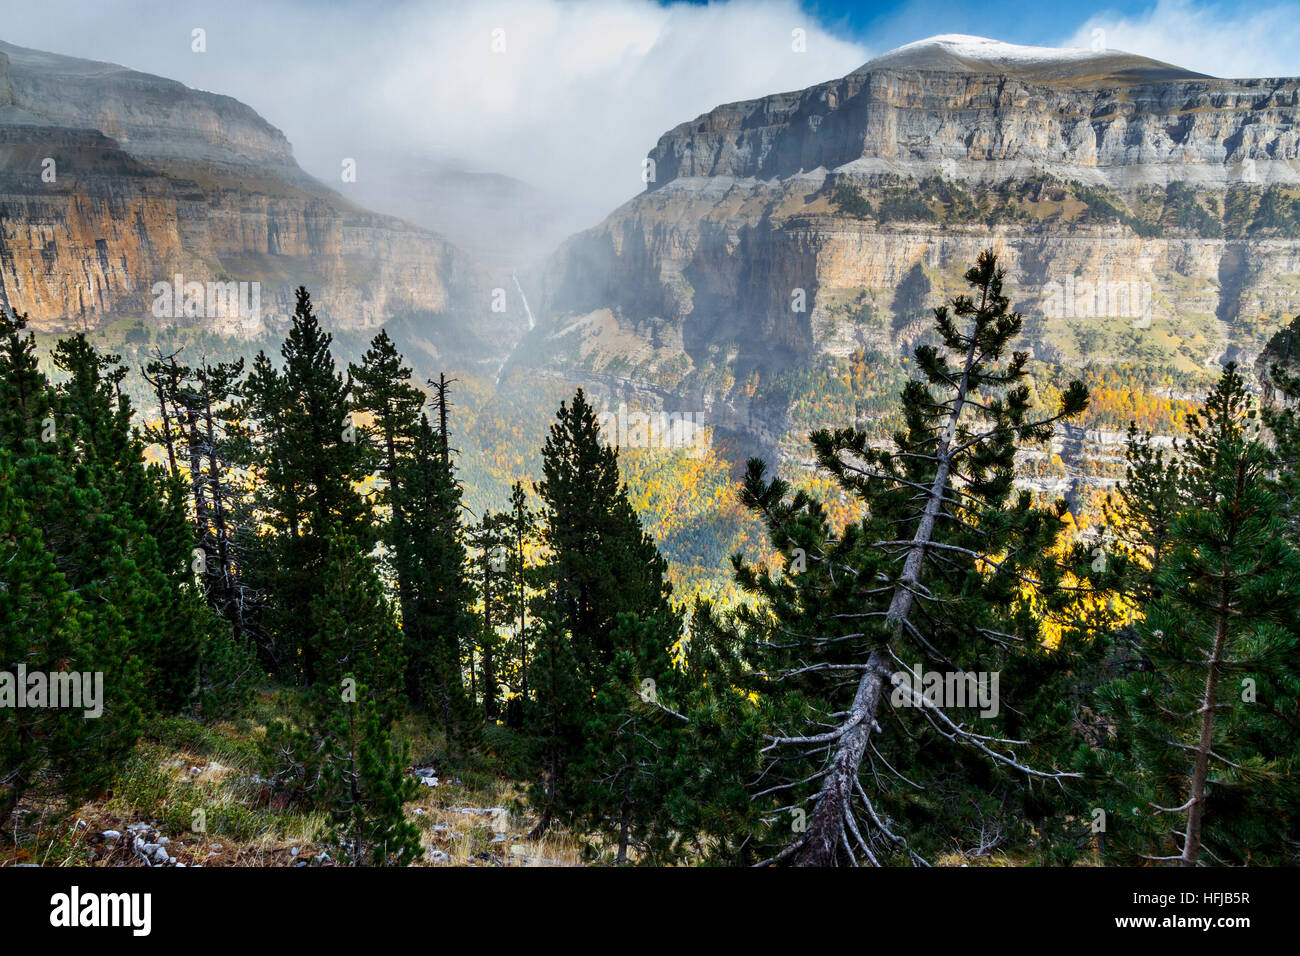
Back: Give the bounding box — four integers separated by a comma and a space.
858, 34, 1204, 82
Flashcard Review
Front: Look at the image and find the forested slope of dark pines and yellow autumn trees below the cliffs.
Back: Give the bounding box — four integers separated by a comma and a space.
0, 251, 1300, 866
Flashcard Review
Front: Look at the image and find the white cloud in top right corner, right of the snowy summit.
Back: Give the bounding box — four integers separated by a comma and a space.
1061, 0, 1300, 77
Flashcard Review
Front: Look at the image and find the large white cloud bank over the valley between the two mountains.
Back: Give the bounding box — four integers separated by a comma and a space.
3, 0, 867, 230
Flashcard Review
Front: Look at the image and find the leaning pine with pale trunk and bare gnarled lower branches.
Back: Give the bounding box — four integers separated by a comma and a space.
741, 251, 1087, 866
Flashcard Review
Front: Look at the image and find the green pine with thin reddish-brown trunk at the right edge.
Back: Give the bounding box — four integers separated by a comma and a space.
1093, 364, 1300, 866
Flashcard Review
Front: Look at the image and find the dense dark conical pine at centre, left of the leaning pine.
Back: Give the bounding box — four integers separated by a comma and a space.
533, 389, 684, 862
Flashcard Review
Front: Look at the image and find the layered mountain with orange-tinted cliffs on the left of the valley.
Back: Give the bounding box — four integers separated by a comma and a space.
0, 36, 512, 355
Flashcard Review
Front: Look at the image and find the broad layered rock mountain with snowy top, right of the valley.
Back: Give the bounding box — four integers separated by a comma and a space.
516, 35, 1300, 484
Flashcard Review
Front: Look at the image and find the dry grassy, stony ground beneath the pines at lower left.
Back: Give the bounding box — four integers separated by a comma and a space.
0, 697, 582, 866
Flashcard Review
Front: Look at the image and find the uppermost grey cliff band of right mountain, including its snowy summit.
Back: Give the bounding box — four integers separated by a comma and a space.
650, 36, 1300, 189
